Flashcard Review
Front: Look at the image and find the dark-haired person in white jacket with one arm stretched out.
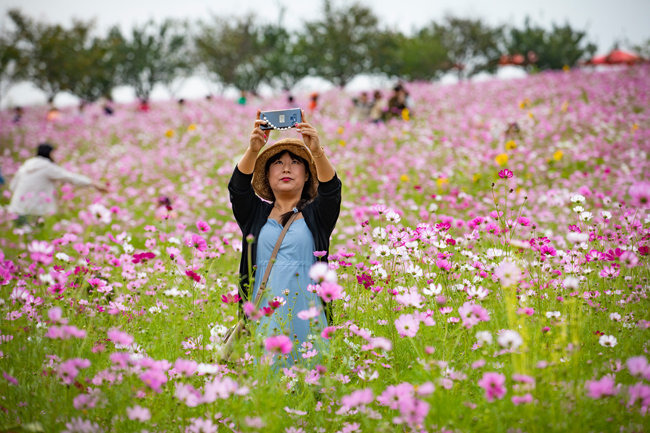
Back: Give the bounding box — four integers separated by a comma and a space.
8, 143, 106, 219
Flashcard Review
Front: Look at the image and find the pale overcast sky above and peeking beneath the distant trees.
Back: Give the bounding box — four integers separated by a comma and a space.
0, 0, 650, 106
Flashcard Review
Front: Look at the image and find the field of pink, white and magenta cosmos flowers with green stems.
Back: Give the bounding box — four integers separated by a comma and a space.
0, 66, 650, 432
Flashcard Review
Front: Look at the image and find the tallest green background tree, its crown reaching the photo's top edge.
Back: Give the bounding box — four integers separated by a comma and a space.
296, 0, 380, 87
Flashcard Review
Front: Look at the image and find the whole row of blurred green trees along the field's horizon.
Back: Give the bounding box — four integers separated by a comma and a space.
0, 0, 596, 102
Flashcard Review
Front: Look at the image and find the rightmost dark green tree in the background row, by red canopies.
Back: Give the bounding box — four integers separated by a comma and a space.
505, 18, 596, 70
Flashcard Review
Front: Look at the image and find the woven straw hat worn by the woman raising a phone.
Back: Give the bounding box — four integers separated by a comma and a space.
252, 138, 318, 201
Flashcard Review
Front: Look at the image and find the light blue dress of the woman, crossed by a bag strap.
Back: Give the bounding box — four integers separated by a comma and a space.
253, 218, 327, 365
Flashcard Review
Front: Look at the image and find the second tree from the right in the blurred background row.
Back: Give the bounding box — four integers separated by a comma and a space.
431, 16, 503, 78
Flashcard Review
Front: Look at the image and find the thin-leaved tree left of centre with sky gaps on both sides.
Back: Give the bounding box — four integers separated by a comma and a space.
119, 19, 191, 99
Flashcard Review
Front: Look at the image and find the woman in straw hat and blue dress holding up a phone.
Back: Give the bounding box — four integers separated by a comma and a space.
228, 111, 341, 364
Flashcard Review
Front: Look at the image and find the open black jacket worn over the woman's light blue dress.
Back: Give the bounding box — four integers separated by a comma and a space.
228, 167, 342, 324
